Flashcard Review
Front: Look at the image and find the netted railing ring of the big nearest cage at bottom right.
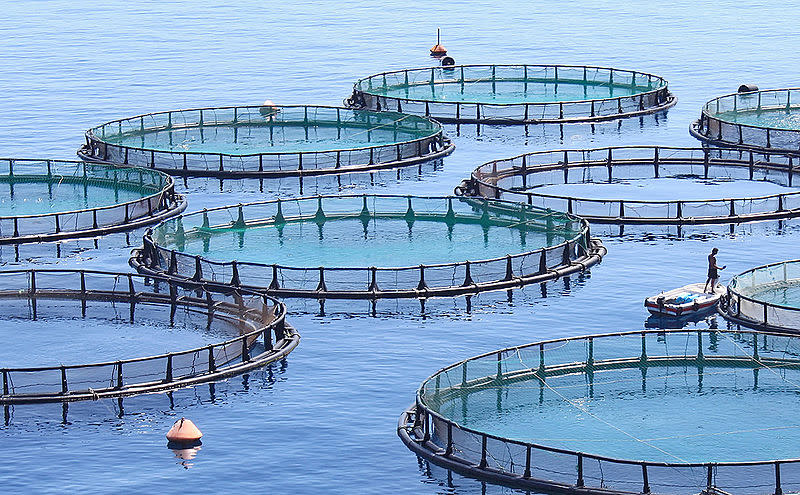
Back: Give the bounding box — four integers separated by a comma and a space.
397, 329, 800, 495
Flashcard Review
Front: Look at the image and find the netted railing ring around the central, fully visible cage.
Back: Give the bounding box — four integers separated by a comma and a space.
131, 195, 606, 300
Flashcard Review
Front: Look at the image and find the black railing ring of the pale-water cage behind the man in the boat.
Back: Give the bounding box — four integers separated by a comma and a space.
456, 146, 800, 225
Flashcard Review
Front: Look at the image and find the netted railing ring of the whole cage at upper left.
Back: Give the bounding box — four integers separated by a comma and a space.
83, 105, 455, 178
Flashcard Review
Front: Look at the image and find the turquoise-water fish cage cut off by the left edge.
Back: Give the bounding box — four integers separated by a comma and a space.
0, 158, 186, 244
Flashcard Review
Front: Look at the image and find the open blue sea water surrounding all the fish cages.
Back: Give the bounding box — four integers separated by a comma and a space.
0, 0, 800, 494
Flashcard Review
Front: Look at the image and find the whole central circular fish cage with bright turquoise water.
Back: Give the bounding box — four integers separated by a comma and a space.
131, 195, 605, 299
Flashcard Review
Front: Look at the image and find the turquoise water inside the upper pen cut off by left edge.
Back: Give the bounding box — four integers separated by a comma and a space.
0, 182, 147, 216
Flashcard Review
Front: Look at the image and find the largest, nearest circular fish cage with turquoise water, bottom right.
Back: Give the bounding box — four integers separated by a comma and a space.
398, 330, 800, 495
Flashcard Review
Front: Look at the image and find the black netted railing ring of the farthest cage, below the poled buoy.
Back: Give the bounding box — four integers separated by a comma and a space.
345, 65, 677, 125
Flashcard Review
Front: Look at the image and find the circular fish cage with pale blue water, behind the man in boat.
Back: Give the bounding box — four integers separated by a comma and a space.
456, 146, 800, 225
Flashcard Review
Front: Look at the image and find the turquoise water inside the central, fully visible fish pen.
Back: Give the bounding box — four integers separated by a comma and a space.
178, 218, 577, 267
